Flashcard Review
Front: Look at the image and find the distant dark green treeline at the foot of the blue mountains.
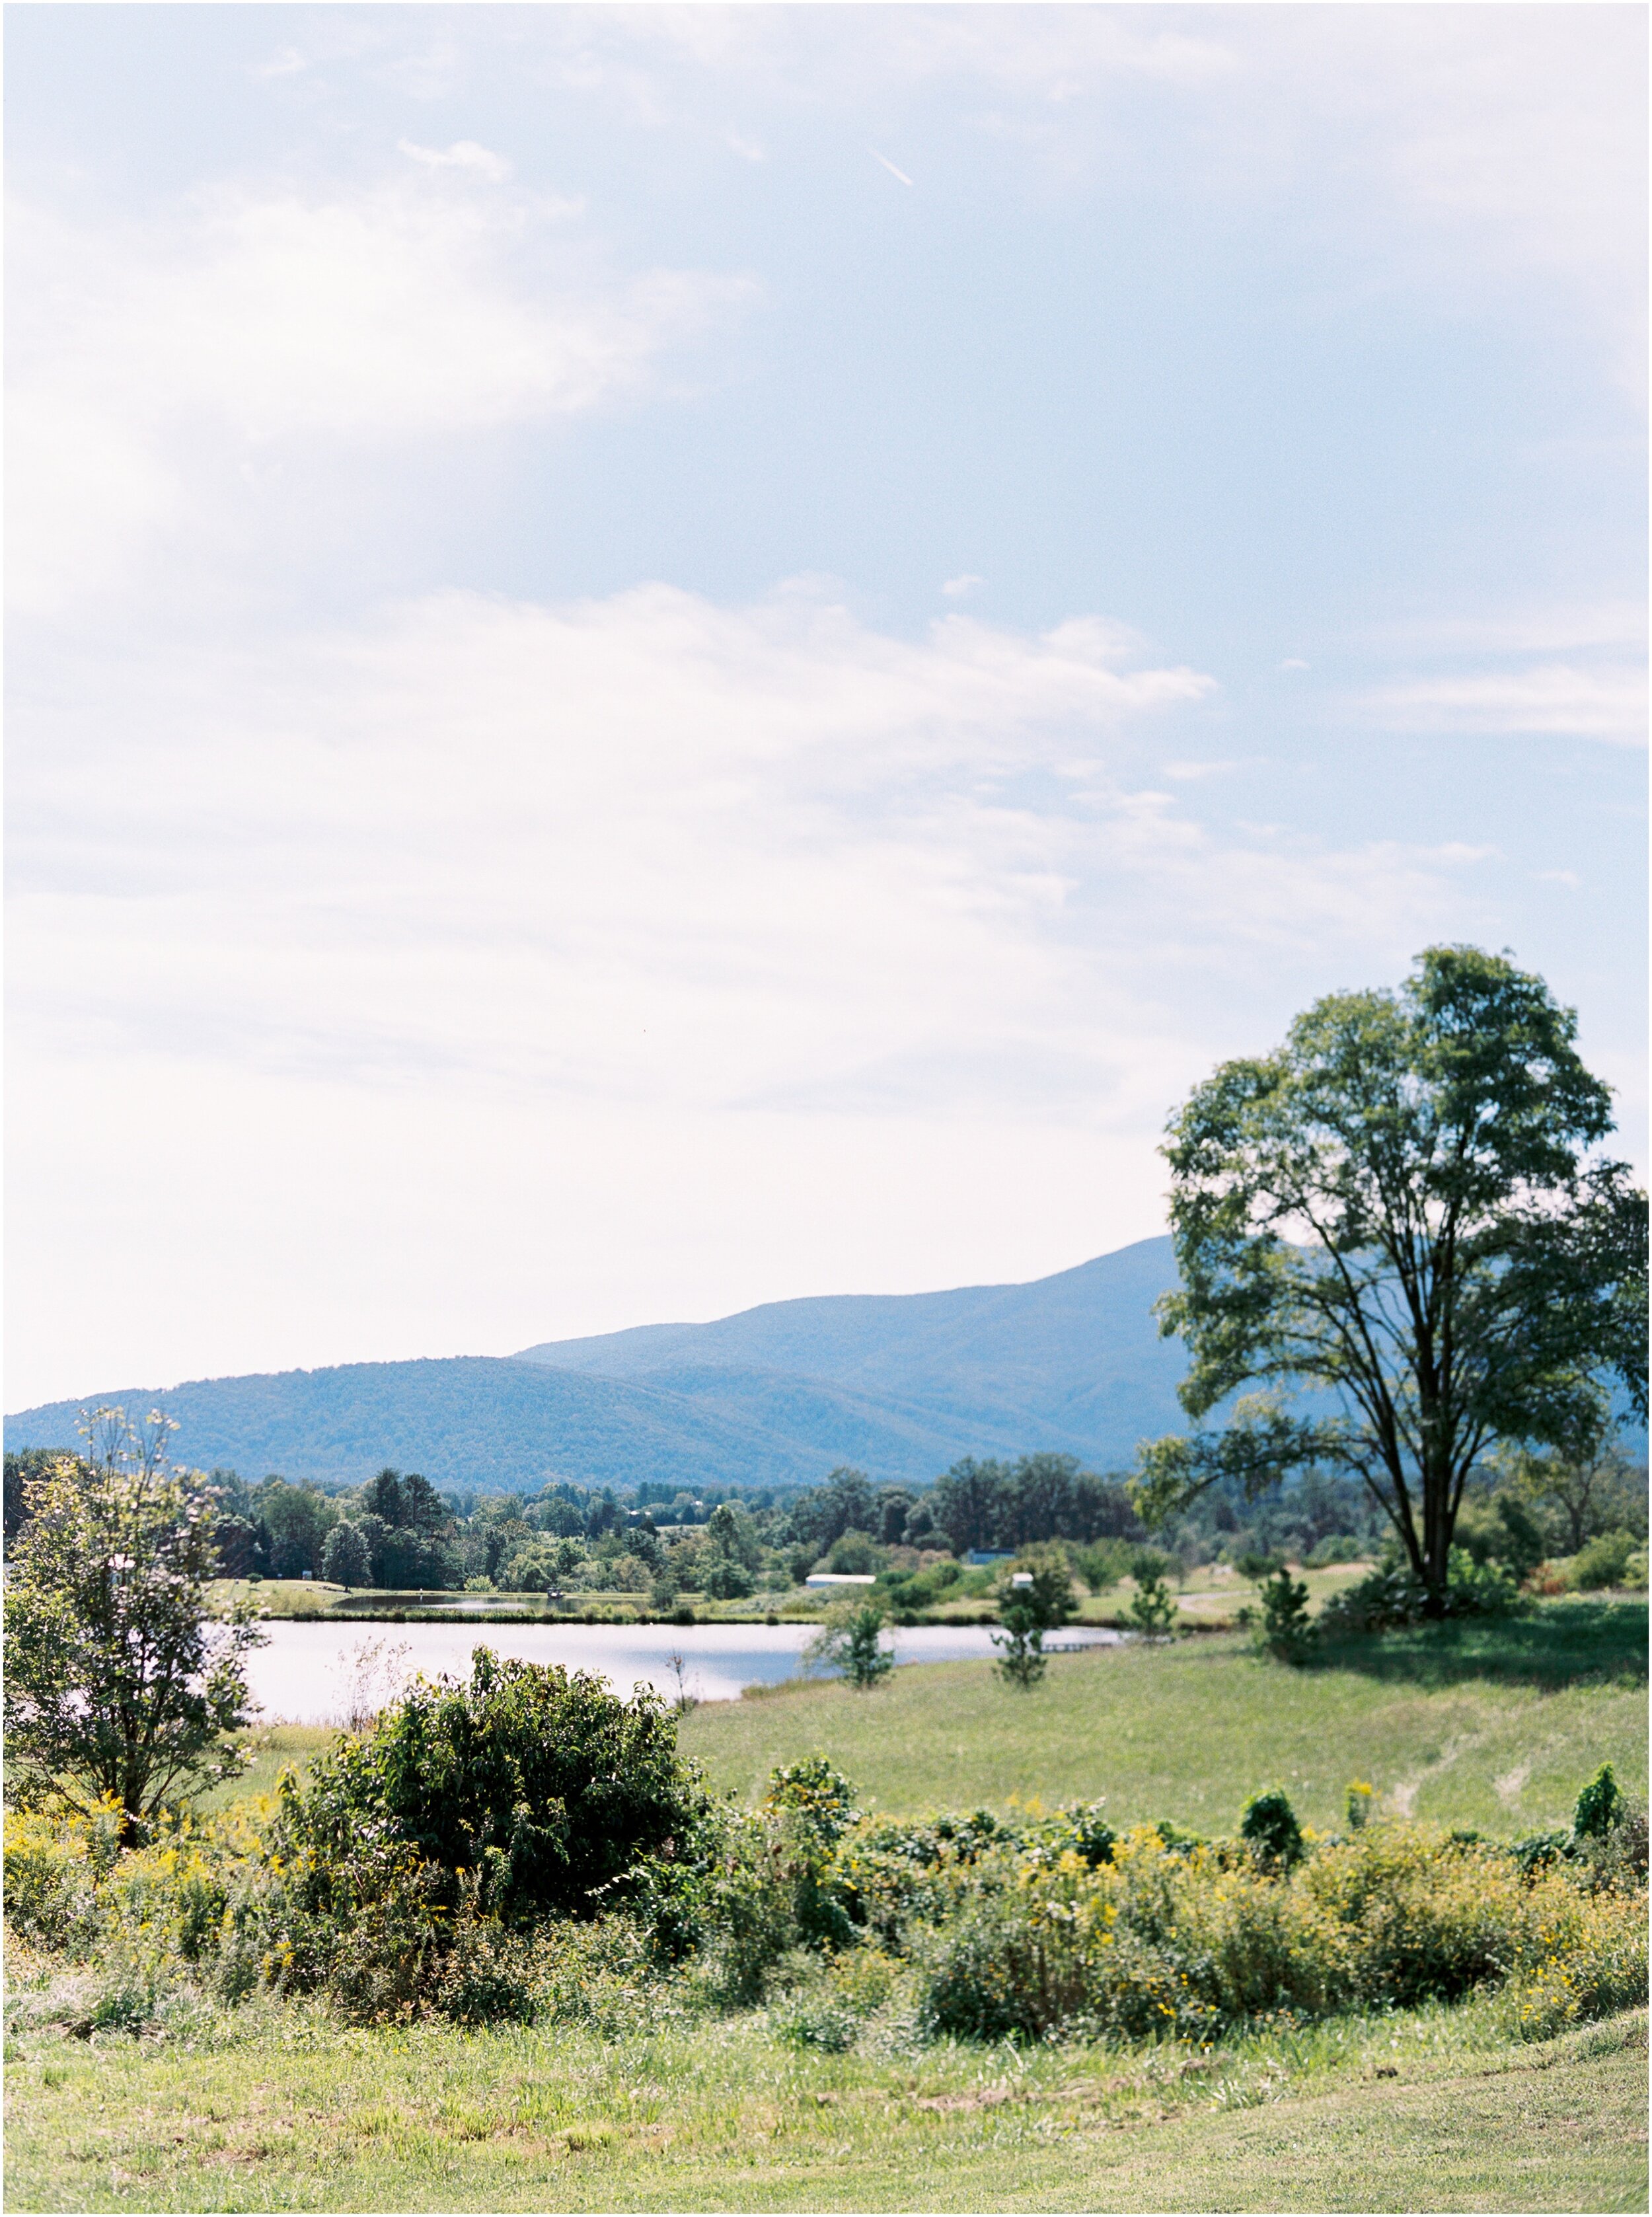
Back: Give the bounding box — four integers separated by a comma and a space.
5, 1450, 1647, 1605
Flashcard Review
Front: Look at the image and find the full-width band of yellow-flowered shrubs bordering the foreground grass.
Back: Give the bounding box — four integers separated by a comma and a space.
5, 1720, 1645, 2053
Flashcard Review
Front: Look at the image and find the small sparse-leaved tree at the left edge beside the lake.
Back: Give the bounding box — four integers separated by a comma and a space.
5, 1410, 262, 1834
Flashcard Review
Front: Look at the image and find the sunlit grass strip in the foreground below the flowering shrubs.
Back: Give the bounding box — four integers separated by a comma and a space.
5, 2004, 1645, 2210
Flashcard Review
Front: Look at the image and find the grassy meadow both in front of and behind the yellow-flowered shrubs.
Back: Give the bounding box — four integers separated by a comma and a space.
7, 1597, 1647, 2210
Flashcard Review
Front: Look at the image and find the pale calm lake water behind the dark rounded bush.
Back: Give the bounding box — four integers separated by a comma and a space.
248, 1623, 1120, 1725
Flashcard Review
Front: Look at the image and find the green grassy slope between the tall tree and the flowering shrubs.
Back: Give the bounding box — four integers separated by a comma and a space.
681, 1600, 1647, 1836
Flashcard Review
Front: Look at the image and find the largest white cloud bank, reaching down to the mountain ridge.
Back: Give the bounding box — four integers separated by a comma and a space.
9, 585, 1507, 1401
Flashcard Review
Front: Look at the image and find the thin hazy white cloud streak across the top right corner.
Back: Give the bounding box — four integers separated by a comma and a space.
563, 5, 1645, 363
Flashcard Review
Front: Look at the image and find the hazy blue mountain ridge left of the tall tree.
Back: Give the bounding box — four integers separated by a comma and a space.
5, 1239, 1182, 1492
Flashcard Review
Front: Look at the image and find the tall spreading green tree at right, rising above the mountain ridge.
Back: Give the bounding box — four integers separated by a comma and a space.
1137, 947, 1645, 1612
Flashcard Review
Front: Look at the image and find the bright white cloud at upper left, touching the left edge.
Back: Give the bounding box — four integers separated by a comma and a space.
7, 175, 749, 610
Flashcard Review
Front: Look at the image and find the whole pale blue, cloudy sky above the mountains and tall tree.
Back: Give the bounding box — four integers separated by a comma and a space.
5, 5, 1645, 1408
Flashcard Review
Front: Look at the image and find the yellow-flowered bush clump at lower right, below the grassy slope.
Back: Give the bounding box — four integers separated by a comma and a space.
911, 1824, 1645, 2042
